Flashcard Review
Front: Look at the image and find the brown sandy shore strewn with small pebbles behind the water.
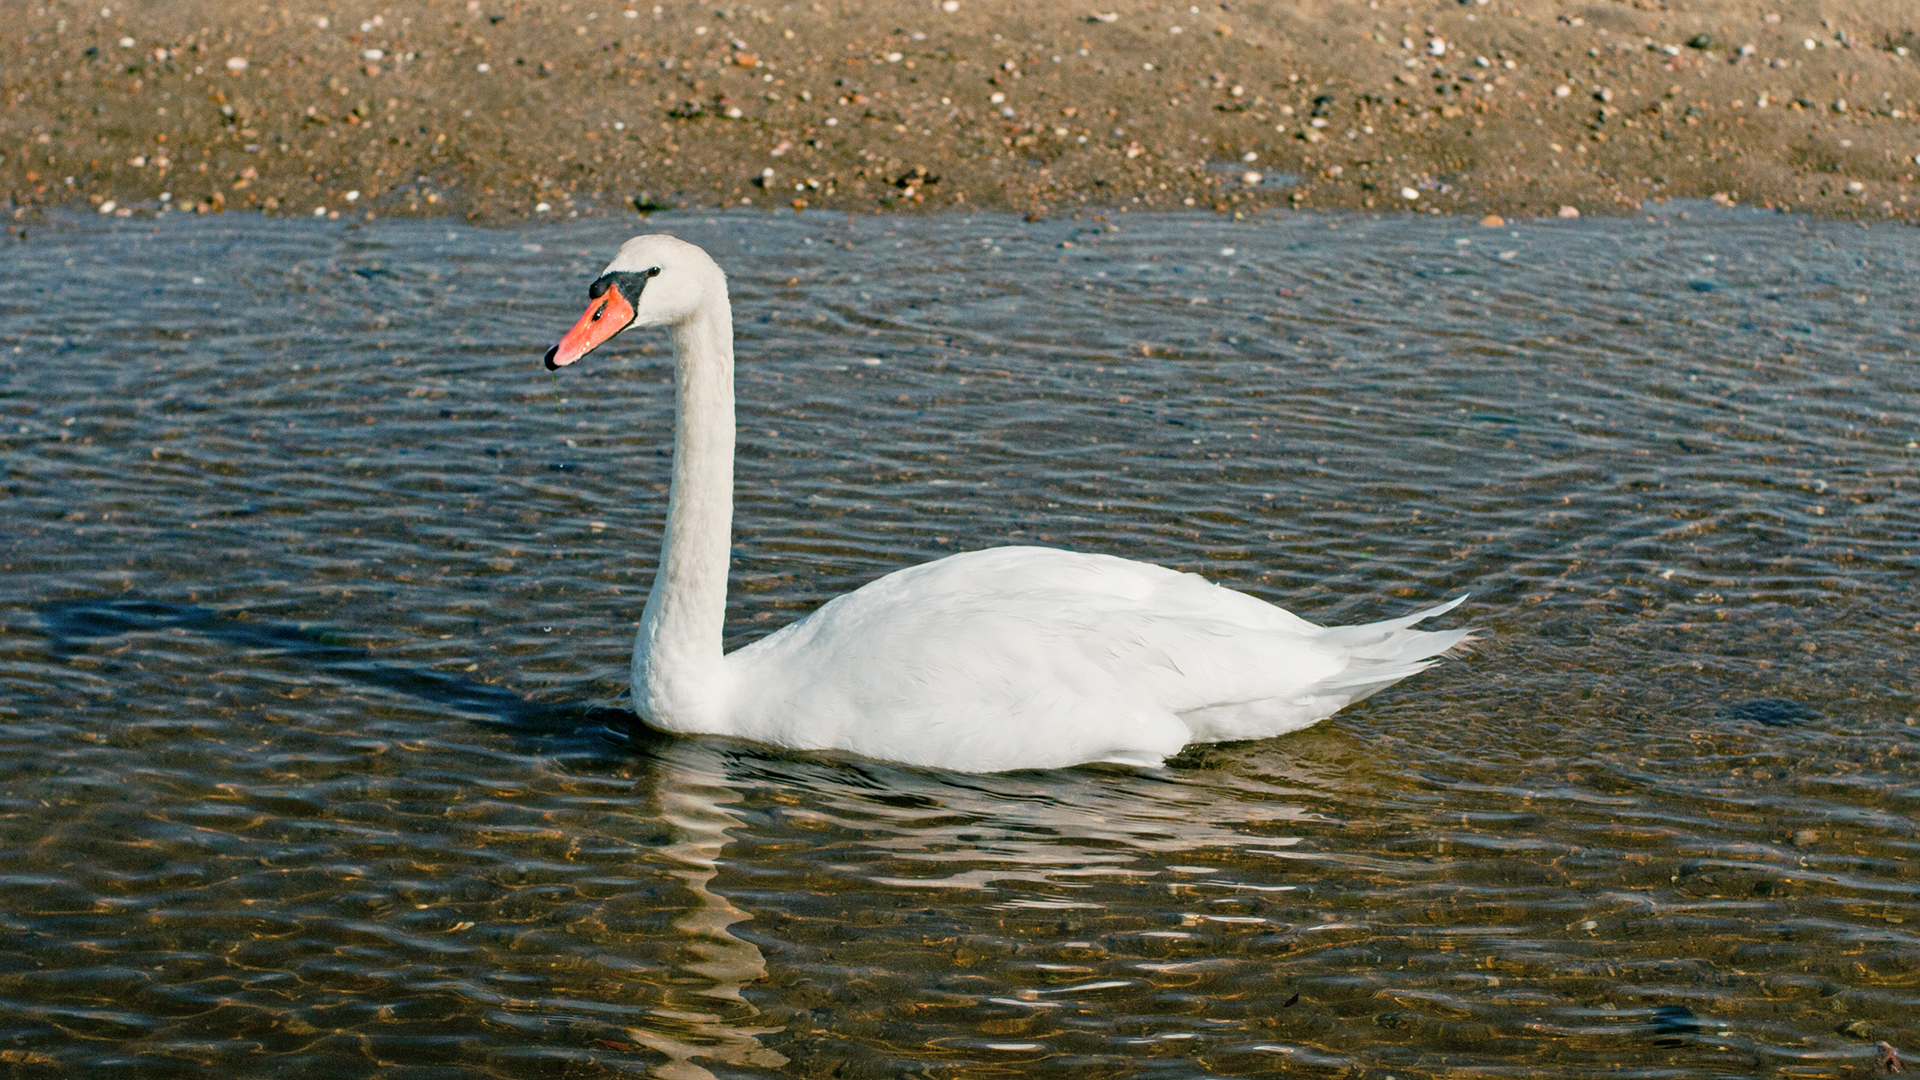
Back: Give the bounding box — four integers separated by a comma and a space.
0, 0, 1920, 219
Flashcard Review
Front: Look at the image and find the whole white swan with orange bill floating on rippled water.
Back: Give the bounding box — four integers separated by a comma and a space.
547, 234, 1467, 773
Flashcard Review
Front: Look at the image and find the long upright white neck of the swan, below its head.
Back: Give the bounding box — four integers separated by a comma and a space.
634, 294, 733, 732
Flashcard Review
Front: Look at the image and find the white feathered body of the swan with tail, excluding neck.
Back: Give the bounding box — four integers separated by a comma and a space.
724, 548, 1467, 771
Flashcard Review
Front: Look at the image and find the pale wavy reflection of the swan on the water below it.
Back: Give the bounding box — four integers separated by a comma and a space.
628, 732, 1346, 1080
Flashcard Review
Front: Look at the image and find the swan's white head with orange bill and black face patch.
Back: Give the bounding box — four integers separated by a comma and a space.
547, 233, 726, 371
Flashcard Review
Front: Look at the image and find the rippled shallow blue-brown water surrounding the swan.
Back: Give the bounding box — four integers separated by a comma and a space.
0, 208, 1920, 1080
